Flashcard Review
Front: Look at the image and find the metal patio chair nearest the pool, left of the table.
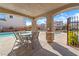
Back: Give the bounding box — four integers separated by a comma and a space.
10, 32, 28, 56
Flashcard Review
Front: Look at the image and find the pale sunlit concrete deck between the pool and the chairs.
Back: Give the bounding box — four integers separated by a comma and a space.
0, 36, 15, 56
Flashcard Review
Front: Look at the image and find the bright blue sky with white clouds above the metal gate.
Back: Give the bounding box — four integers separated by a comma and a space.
54, 10, 79, 23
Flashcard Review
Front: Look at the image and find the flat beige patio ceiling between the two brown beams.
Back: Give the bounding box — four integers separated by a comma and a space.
0, 3, 66, 17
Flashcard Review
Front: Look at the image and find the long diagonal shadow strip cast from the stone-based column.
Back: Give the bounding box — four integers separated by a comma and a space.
50, 42, 77, 56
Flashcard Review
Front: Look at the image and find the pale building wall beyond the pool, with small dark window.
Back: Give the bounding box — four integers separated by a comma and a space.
0, 14, 25, 28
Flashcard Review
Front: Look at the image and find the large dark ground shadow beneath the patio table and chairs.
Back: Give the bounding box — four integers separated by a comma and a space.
8, 36, 57, 56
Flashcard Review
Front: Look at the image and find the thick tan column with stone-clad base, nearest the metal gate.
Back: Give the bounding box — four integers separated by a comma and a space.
46, 15, 54, 43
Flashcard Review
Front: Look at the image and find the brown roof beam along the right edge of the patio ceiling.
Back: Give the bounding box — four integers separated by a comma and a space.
35, 3, 79, 18
